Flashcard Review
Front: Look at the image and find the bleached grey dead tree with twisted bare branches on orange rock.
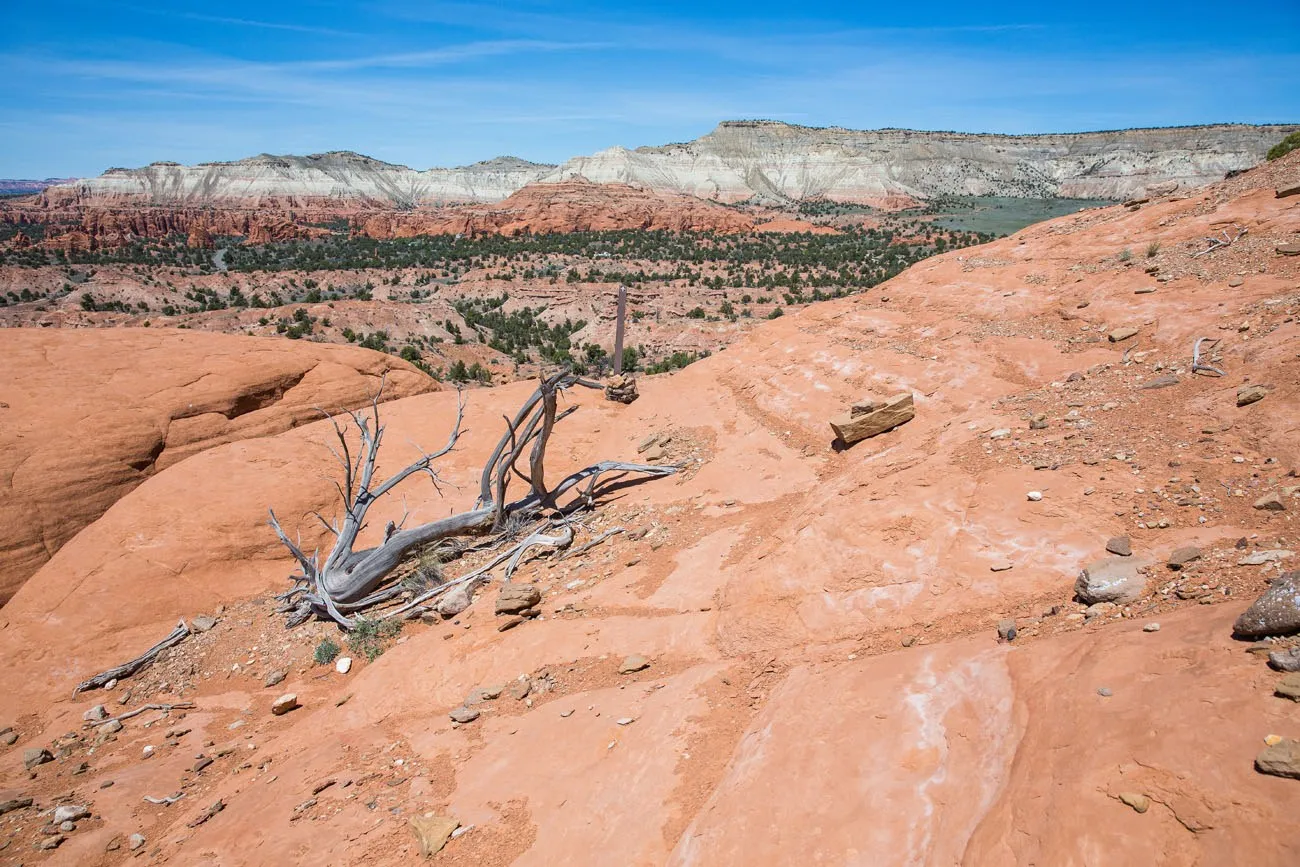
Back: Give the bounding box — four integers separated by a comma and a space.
270, 372, 677, 629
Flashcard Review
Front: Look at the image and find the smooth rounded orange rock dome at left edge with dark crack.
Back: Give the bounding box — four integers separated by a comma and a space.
0, 329, 437, 602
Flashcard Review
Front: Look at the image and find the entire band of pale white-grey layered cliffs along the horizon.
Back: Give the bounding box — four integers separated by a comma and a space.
40, 121, 1300, 209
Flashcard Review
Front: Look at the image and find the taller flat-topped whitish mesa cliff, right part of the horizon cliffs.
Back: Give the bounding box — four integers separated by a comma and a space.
546, 121, 1296, 207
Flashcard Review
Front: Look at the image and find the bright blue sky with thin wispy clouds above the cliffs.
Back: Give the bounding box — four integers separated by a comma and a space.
0, 0, 1300, 177
